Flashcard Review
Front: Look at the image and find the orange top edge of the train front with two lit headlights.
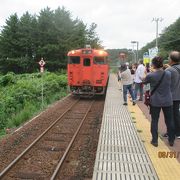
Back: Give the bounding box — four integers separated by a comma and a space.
67, 48, 108, 56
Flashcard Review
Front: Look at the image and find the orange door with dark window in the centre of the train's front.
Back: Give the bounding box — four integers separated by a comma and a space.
82, 57, 92, 85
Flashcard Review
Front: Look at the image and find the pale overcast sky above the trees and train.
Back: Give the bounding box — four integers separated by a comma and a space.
0, 0, 180, 49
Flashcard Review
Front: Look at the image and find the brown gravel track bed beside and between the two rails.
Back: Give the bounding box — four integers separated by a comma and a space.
0, 96, 104, 180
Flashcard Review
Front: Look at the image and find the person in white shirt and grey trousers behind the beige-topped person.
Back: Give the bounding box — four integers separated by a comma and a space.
134, 60, 146, 101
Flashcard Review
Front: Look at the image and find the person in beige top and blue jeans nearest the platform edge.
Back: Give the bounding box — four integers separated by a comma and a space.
119, 64, 136, 105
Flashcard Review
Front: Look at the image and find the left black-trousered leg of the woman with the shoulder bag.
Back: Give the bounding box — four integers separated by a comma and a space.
150, 106, 161, 143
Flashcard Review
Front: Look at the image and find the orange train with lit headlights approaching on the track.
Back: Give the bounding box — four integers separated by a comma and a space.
67, 47, 109, 95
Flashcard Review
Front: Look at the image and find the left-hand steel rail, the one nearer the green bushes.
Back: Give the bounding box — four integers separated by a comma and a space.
0, 99, 80, 179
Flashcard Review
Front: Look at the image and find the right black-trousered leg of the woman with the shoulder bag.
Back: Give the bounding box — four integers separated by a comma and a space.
162, 106, 175, 145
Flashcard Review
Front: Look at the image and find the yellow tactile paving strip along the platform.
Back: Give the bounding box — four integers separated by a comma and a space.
128, 99, 180, 180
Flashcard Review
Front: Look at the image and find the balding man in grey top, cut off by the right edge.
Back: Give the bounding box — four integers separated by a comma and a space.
163, 51, 180, 139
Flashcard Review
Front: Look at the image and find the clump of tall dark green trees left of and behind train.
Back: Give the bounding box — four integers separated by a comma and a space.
0, 7, 101, 73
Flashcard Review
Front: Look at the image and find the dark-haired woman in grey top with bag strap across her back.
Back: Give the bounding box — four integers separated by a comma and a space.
144, 56, 175, 147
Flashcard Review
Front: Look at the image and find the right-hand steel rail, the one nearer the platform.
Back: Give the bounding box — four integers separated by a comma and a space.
50, 100, 95, 180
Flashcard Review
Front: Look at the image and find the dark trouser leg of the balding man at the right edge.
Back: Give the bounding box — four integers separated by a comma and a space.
173, 101, 180, 138
